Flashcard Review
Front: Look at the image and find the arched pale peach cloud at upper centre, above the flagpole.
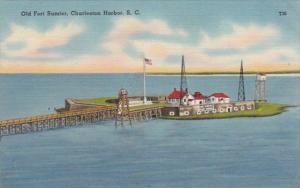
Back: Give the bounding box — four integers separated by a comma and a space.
102, 18, 188, 52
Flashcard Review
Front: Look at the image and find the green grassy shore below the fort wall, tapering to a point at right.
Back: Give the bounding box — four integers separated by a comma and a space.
162, 102, 289, 120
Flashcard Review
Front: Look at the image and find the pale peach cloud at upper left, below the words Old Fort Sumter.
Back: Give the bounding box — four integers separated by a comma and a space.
0, 22, 84, 58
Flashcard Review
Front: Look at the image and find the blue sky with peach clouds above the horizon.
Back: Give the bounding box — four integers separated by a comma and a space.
0, 0, 300, 73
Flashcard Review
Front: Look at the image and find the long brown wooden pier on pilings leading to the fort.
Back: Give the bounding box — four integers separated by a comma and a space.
0, 106, 162, 137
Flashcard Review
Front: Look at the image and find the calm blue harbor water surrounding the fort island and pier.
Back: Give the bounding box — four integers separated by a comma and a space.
0, 74, 300, 188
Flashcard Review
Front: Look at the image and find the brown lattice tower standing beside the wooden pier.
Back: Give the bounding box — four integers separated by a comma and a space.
115, 89, 131, 126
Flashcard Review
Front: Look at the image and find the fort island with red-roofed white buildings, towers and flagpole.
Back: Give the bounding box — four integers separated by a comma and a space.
58, 60, 289, 121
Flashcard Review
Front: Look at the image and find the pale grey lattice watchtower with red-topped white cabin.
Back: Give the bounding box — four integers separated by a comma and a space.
254, 73, 267, 101
